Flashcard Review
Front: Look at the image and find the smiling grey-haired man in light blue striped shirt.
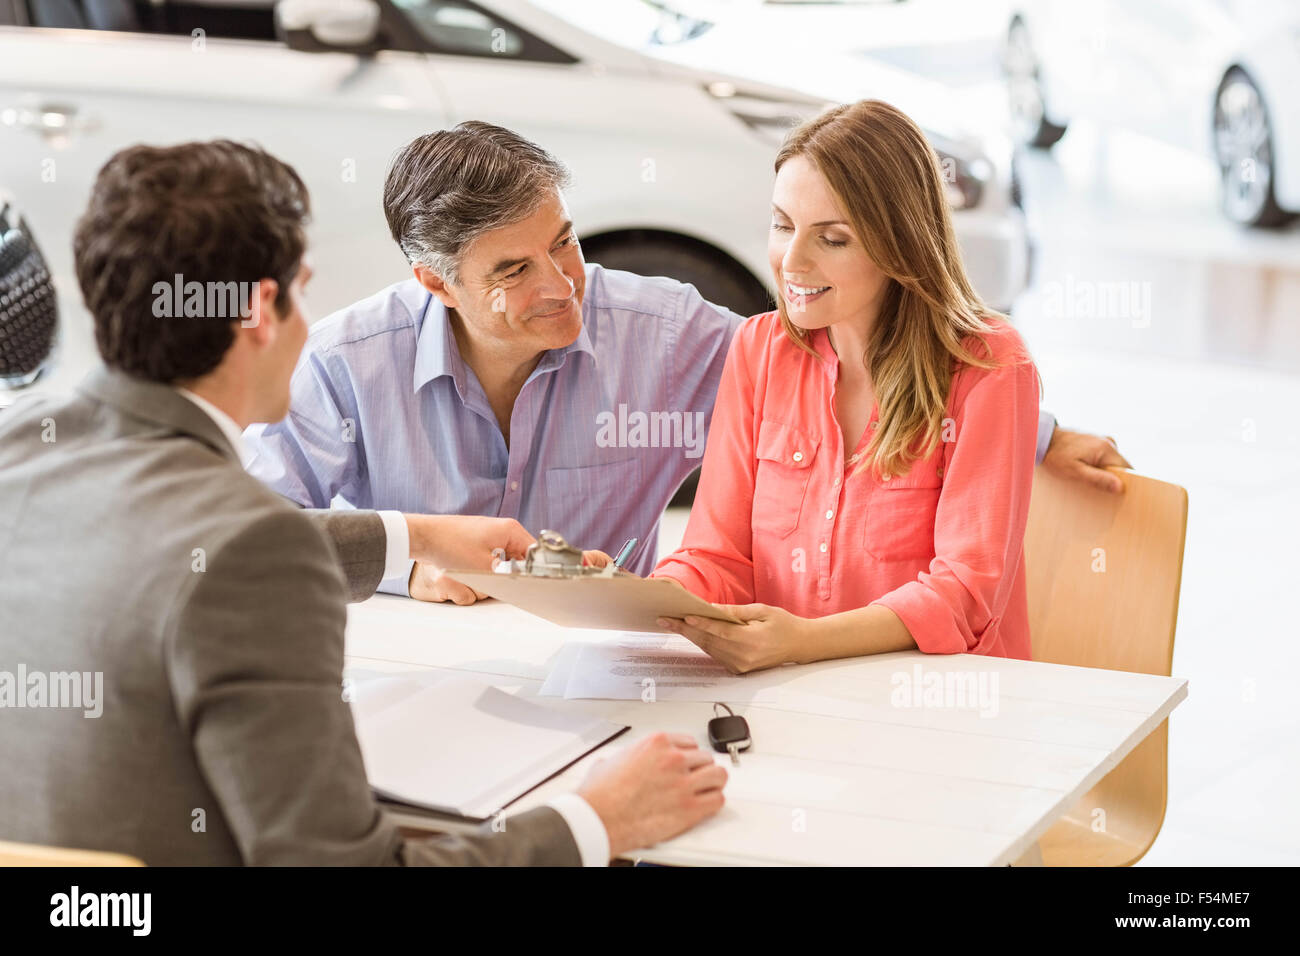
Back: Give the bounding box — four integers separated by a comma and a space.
247, 122, 1127, 604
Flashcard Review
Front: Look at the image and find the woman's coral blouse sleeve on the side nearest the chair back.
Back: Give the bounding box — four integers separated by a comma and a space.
872, 356, 1039, 654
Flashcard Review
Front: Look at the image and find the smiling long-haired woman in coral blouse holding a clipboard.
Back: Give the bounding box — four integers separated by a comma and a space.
654, 100, 1040, 671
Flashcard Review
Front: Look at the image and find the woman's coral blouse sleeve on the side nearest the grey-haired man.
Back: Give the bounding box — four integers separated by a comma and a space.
651, 325, 754, 604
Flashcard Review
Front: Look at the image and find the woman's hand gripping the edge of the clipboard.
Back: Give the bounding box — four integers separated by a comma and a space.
659, 604, 811, 674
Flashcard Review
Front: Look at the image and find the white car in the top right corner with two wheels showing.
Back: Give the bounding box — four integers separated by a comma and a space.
1004, 0, 1300, 226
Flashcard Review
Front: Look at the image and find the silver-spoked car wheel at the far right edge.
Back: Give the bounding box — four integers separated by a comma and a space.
1214, 66, 1294, 226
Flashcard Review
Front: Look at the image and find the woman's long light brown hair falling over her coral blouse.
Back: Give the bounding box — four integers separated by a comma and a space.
776, 100, 1000, 475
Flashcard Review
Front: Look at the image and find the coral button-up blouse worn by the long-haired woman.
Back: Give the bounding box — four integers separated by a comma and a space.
654, 312, 1039, 659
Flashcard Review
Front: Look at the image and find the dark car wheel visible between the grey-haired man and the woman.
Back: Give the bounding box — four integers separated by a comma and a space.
582, 233, 775, 316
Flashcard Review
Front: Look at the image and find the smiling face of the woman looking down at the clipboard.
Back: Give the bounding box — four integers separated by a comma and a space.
767, 155, 889, 329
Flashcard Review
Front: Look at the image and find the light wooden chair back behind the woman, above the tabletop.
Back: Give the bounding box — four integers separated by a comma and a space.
1024, 467, 1187, 676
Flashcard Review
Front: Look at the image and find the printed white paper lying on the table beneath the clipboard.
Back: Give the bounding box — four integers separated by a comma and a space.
537, 632, 789, 702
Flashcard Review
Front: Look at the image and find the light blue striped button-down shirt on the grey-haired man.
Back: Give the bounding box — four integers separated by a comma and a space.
246, 264, 742, 594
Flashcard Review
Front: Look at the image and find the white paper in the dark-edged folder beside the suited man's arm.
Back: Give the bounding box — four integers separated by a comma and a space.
351, 674, 627, 819
